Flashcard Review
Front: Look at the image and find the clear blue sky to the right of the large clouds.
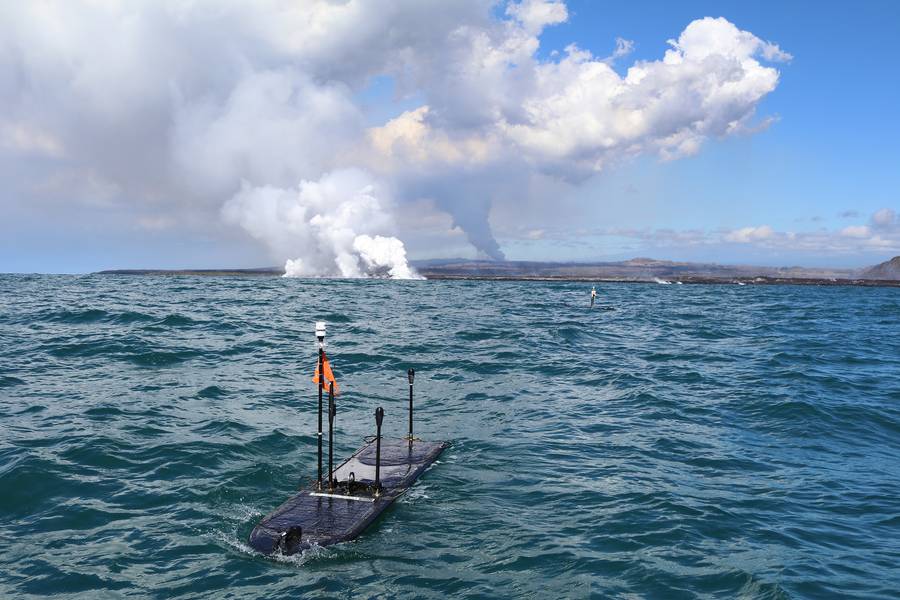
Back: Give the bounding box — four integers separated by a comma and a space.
500, 1, 900, 266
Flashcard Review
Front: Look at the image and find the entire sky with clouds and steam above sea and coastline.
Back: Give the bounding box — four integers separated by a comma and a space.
0, 0, 900, 278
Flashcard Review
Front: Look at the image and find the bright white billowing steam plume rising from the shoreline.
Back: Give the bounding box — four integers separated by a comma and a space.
223, 169, 419, 279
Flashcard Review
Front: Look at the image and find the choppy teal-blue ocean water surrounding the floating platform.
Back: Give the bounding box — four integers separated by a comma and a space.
0, 276, 900, 598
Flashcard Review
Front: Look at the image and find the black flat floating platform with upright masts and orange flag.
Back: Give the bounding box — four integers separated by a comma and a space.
250, 322, 447, 555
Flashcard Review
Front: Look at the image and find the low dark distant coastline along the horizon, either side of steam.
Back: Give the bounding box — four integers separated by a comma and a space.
98, 257, 900, 287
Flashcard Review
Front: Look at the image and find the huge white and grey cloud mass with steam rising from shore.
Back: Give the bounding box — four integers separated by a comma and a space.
0, 0, 790, 277
